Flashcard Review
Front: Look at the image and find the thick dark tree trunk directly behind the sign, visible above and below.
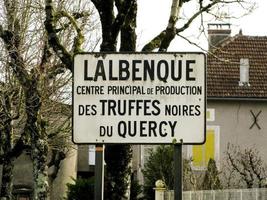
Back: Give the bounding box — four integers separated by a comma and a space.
89, 0, 137, 200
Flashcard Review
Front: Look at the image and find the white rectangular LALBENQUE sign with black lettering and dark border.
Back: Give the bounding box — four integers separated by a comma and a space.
73, 53, 206, 144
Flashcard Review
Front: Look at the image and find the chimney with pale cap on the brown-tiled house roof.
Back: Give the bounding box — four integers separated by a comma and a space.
208, 23, 231, 50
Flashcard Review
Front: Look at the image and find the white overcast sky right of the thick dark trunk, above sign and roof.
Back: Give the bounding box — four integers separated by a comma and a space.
137, 0, 267, 51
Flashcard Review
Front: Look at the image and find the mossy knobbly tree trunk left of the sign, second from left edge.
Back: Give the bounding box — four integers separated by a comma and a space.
25, 87, 49, 200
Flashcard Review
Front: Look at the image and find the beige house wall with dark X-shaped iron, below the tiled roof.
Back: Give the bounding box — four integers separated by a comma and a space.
207, 100, 267, 163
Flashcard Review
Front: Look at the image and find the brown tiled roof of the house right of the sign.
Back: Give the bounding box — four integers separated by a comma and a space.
207, 34, 267, 99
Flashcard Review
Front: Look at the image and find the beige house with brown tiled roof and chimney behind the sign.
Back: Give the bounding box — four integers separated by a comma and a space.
134, 24, 267, 182
